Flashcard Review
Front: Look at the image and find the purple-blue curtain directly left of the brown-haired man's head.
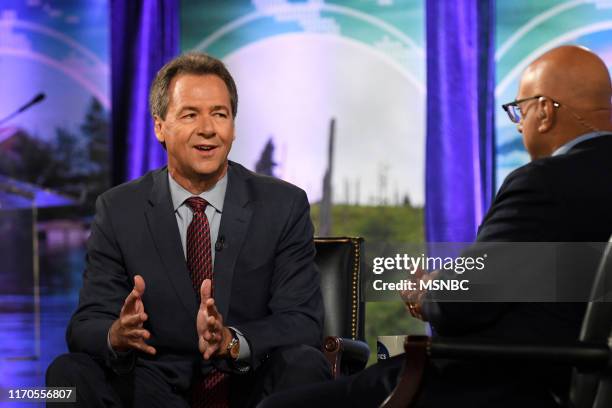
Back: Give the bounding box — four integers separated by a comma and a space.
110, 0, 180, 184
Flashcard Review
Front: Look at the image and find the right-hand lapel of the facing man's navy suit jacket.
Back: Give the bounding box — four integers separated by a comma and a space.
214, 162, 252, 317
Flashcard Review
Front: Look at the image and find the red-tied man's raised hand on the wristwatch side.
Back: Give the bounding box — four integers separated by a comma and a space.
196, 279, 232, 360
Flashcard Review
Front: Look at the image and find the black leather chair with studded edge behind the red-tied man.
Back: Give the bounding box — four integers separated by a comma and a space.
315, 237, 370, 378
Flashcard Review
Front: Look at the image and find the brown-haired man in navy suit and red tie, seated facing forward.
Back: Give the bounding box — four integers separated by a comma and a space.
47, 53, 330, 407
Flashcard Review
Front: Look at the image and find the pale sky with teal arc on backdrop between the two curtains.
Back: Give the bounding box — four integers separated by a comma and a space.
181, 0, 425, 205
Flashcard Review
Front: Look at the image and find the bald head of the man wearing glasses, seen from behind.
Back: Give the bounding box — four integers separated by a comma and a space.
517, 45, 612, 159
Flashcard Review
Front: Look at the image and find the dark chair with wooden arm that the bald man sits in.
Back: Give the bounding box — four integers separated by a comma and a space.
381, 237, 612, 408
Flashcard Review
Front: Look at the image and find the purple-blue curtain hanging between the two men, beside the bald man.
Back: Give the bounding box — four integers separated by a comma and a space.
425, 0, 495, 242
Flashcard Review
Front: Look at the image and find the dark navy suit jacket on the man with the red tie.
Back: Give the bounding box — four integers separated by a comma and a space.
66, 162, 323, 390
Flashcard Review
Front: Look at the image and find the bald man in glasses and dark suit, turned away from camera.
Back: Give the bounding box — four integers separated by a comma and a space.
260, 46, 612, 408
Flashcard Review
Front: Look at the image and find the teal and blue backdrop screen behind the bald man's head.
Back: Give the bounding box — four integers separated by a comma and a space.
495, 0, 612, 186
